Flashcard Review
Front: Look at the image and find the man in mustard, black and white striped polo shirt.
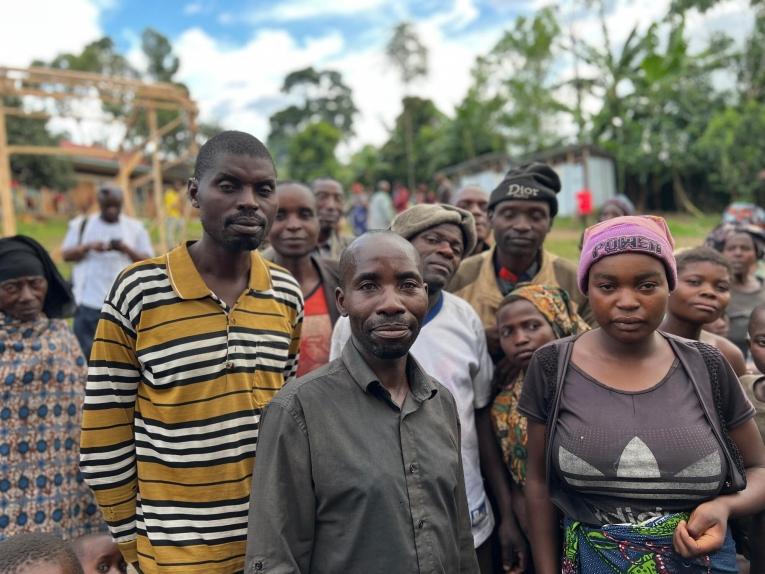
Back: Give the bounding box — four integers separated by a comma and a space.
80, 131, 303, 574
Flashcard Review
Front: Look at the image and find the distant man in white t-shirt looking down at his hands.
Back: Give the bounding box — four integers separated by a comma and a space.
61, 186, 154, 358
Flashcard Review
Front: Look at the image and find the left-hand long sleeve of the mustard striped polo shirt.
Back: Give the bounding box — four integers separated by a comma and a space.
80, 270, 141, 562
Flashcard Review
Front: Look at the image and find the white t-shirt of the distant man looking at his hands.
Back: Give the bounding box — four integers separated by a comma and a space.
61, 214, 154, 309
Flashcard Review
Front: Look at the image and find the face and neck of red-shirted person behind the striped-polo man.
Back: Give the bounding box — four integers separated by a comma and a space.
268, 184, 321, 295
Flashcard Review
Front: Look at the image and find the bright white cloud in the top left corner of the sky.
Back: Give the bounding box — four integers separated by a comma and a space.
0, 0, 103, 67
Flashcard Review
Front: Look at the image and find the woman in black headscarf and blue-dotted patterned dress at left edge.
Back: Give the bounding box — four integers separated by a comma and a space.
0, 235, 101, 540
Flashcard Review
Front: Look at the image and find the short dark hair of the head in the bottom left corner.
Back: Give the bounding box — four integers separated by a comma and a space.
0, 533, 83, 574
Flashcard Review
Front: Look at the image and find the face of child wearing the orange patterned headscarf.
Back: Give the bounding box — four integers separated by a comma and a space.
497, 299, 555, 369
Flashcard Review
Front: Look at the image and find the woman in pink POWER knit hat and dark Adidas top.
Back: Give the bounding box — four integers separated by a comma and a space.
519, 216, 765, 574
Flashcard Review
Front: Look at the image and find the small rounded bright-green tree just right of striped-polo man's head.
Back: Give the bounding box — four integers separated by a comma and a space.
287, 121, 343, 182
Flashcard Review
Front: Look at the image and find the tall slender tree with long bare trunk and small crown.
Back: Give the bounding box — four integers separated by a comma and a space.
385, 22, 428, 191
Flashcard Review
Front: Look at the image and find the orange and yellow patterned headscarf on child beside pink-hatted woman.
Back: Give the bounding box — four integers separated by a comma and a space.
500, 283, 590, 339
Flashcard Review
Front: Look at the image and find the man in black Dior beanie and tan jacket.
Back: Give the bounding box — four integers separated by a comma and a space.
449, 163, 592, 351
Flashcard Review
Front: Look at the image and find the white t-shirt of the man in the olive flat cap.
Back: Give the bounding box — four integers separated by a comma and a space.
330, 291, 494, 548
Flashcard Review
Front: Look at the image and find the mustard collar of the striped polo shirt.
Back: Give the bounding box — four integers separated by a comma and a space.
165, 241, 271, 299
